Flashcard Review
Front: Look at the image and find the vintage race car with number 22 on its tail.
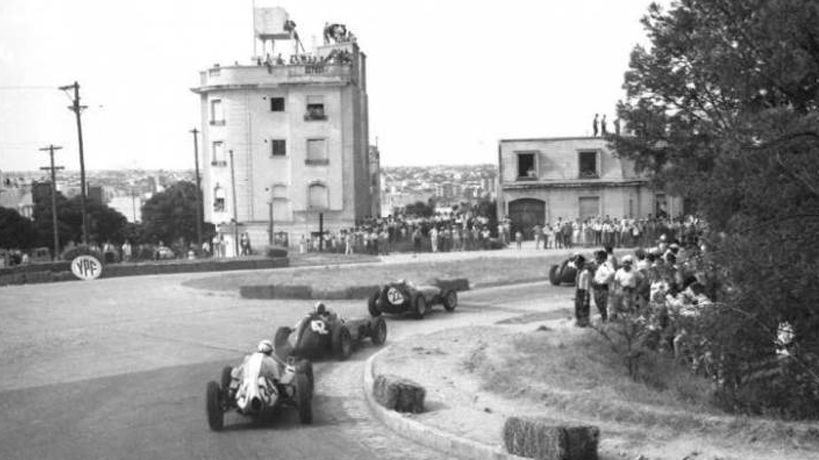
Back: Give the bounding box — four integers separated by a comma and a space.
367, 280, 458, 319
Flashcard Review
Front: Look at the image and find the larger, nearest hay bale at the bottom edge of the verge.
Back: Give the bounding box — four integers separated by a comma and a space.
503, 417, 600, 460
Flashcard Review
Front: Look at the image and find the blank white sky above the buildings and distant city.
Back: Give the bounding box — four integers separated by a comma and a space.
0, 0, 663, 171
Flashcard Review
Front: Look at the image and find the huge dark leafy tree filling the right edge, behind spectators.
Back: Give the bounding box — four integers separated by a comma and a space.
610, 0, 819, 416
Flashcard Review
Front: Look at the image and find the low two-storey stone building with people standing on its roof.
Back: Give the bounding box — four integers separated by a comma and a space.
498, 137, 682, 233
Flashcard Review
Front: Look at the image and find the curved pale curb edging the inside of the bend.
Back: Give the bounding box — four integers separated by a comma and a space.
362, 347, 526, 460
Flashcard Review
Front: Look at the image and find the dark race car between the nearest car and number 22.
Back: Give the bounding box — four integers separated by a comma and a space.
274, 304, 387, 360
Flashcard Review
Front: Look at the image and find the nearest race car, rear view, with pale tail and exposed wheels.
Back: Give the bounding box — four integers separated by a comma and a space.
206, 353, 313, 431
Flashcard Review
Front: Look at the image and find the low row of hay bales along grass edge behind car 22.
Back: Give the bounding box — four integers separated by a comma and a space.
239, 278, 469, 300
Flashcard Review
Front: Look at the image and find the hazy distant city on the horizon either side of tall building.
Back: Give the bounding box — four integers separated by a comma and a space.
0, 164, 498, 222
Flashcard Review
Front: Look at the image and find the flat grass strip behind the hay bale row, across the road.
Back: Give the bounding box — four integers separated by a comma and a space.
184, 255, 565, 290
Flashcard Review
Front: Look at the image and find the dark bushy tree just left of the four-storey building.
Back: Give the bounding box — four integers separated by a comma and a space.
142, 181, 202, 247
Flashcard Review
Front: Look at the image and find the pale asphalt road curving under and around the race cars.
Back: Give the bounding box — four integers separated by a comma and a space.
0, 274, 573, 460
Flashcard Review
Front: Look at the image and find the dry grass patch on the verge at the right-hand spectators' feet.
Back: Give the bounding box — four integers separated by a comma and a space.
462, 329, 819, 448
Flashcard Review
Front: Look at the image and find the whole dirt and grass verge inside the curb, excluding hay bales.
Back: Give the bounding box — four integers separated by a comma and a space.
374, 315, 819, 460
